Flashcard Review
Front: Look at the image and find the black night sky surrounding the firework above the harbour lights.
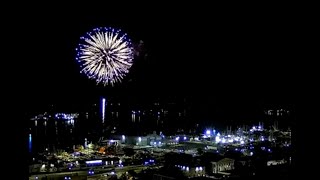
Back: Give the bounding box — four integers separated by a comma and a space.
23, 9, 295, 121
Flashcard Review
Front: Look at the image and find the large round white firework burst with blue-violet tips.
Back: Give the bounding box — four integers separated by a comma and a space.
76, 27, 134, 86
